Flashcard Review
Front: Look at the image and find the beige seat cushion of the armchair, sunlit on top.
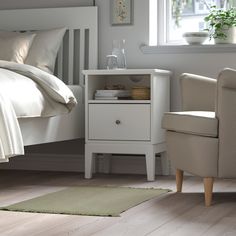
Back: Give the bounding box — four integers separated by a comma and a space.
162, 111, 218, 137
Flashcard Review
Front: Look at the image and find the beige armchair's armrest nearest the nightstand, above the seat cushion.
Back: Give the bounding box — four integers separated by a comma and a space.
180, 73, 217, 111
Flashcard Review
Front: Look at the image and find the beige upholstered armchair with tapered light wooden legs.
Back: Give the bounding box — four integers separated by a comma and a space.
162, 69, 236, 206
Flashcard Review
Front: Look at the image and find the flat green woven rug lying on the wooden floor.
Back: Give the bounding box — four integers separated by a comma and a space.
1, 186, 169, 216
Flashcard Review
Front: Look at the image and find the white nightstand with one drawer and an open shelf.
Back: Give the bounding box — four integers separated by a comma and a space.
83, 69, 171, 181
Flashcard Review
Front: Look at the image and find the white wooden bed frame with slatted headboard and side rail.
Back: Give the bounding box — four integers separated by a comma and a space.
0, 7, 98, 162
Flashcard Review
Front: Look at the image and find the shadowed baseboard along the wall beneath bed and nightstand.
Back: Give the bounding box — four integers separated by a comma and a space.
0, 153, 171, 175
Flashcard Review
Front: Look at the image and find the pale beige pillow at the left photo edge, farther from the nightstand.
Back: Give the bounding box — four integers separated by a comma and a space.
0, 31, 35, 64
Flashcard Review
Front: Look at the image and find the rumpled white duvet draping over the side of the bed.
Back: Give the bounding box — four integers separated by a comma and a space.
0, 60, 76, 162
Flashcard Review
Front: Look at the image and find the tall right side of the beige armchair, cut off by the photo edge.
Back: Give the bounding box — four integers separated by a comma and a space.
216, 69, 236, 178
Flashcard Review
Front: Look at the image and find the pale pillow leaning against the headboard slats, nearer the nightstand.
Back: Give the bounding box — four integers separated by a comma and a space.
25, 28, 66, 74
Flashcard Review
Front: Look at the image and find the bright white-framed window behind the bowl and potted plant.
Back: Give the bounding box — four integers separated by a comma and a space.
149, 0, 235, 46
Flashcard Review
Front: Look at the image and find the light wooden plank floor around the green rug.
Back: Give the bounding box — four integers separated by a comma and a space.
0, 170, 236, 236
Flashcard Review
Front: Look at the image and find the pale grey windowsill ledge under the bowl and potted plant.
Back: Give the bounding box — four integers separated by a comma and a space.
140, 44, 236, 54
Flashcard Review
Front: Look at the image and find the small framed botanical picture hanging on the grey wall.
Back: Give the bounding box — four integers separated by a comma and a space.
110, 0, 133, 25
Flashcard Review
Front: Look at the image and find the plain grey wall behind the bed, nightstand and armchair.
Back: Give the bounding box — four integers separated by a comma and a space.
0, 0, 236, 110
